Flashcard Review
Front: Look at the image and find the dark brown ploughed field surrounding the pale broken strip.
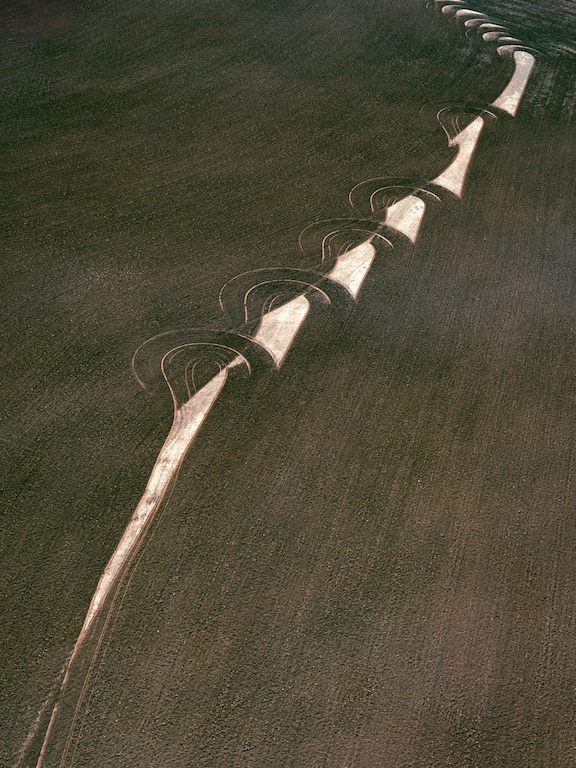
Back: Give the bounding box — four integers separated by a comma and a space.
0, 0, 576, 768
